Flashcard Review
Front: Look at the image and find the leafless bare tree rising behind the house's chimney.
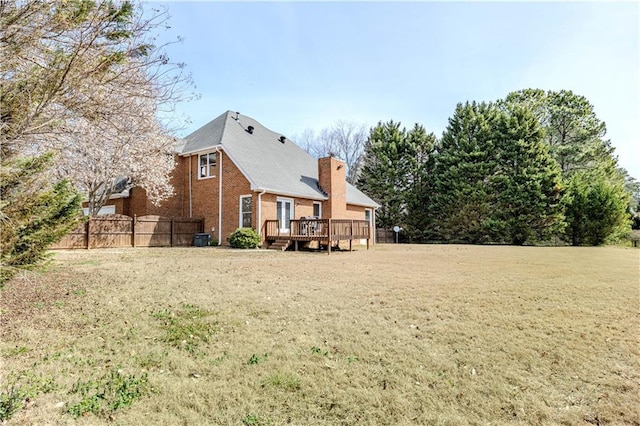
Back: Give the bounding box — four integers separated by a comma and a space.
296, 120, 368, 184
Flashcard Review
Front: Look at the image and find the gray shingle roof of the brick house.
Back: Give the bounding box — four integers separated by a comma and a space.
180, 111, 378, 207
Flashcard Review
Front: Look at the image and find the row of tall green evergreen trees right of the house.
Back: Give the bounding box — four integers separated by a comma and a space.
355, 89, 640, 245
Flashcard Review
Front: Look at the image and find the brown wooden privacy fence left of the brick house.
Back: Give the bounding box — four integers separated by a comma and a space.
52, 214, 204, 249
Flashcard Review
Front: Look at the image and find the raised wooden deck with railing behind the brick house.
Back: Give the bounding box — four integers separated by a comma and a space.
264, 219, 371, 253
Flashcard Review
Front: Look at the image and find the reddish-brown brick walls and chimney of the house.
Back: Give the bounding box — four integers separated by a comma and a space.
104, 151, 376, 245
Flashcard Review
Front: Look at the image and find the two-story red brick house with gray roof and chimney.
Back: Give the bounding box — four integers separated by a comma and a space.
109, 111, 378, 248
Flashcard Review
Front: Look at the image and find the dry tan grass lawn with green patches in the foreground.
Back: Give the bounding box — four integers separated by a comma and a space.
0, 245, 640, 425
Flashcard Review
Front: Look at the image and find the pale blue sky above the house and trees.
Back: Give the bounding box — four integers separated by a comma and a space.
147, 1, 640, 179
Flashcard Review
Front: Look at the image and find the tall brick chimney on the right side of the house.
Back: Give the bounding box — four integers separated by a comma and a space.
318, 156, 347, 219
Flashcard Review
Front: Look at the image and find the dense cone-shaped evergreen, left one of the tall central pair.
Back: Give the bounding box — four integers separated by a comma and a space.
429, 102, 497, 243
